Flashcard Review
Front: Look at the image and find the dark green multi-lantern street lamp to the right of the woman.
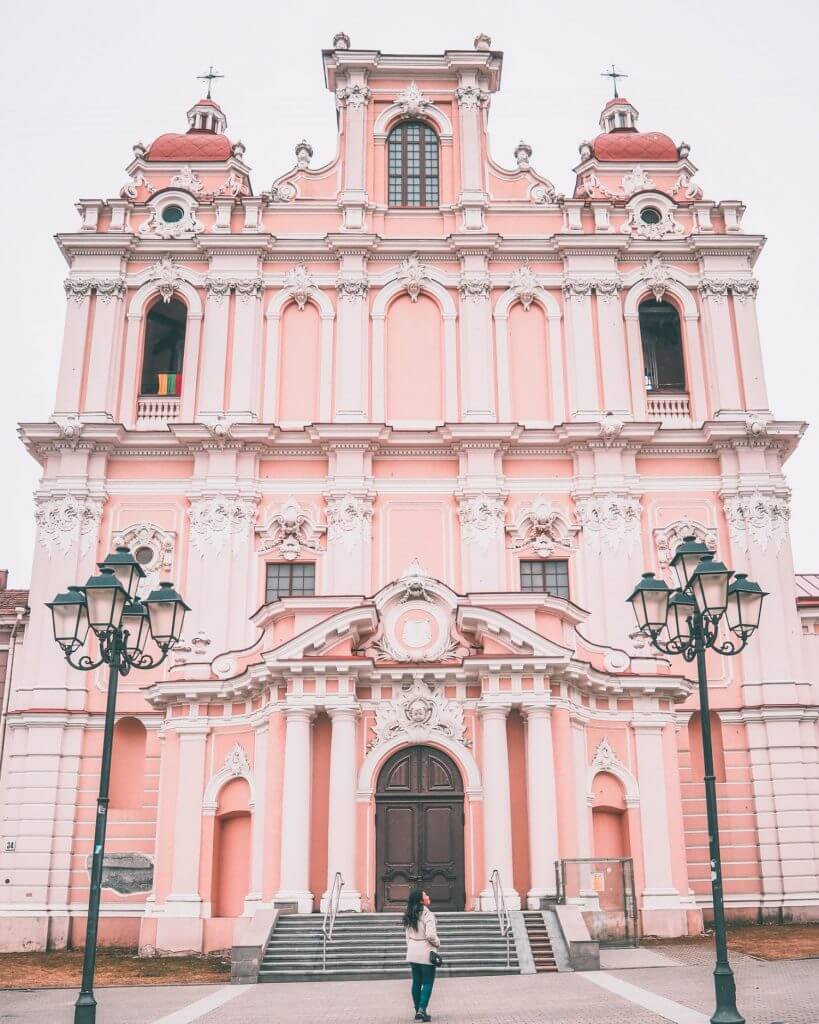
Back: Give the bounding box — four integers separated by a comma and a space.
629, 537, 767, 1024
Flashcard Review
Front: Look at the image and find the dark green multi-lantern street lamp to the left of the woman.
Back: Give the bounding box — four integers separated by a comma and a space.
47, 548, 188, 1024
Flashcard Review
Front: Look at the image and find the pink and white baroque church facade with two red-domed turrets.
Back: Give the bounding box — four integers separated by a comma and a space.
0, 34, 819, 951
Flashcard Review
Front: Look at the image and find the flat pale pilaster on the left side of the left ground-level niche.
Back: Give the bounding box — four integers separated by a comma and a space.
157, 725, 209, 952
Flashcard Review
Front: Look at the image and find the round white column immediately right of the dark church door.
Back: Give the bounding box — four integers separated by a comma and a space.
478, 703, 520, 910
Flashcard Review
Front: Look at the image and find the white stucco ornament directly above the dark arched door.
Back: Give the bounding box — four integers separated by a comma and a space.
370, 673, 470, 749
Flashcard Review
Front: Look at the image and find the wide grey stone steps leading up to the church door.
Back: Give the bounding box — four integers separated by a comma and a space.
259, 913, 520, 981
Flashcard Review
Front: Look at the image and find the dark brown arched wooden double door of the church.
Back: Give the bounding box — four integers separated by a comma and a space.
376, 746, 465, 910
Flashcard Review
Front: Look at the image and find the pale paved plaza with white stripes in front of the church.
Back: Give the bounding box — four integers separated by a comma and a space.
0, 946, 819, 1024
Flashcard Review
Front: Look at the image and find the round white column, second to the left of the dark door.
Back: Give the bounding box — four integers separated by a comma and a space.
275, 707, 315, 913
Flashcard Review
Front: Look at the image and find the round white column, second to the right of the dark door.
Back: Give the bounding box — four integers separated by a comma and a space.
523, 705, 558, 910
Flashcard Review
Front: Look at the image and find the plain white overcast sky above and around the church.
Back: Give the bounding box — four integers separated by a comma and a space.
0, 0, 819, 587
